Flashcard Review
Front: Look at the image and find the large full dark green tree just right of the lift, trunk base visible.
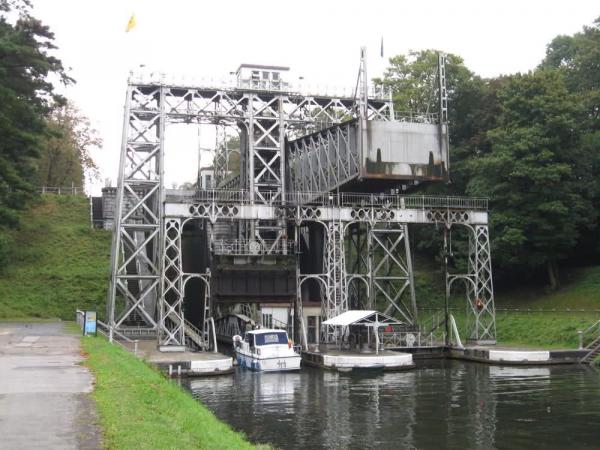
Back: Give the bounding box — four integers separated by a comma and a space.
467, 70, 596, 287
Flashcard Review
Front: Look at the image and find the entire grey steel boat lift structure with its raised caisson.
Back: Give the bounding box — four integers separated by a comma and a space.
107, 49, 496, 351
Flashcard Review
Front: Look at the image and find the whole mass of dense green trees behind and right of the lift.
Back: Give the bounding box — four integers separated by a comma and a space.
376, 19, 600, 288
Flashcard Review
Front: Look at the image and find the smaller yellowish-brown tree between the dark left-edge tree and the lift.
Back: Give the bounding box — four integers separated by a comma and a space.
36, 103, 102, 187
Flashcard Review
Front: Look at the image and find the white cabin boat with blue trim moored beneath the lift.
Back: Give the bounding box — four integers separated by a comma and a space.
233, 329, 301, 372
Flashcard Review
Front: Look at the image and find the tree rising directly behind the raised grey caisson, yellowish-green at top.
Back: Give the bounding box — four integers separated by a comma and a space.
374, 50, 493, 264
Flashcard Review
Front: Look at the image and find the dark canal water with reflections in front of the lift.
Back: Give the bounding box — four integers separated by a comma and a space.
184, 360, 600, 449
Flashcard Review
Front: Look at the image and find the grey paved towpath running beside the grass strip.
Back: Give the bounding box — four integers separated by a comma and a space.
0, 322, 101, 449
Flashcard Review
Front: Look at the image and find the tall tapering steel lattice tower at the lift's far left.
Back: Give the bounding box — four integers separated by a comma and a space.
107, 86, 164, 330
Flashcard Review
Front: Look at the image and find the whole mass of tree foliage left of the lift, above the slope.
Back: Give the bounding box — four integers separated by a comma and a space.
0, 0, 100, 268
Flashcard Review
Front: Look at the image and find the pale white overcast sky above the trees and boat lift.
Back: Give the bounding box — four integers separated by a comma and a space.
33, 0, 600, 193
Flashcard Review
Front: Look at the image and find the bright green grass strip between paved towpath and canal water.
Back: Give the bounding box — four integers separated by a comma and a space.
82, 337, 269, 449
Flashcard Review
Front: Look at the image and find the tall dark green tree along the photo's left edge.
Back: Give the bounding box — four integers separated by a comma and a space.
0, 0, 73, 266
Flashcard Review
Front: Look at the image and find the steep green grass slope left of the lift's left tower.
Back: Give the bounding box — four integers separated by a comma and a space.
0, 195, 110, 320
